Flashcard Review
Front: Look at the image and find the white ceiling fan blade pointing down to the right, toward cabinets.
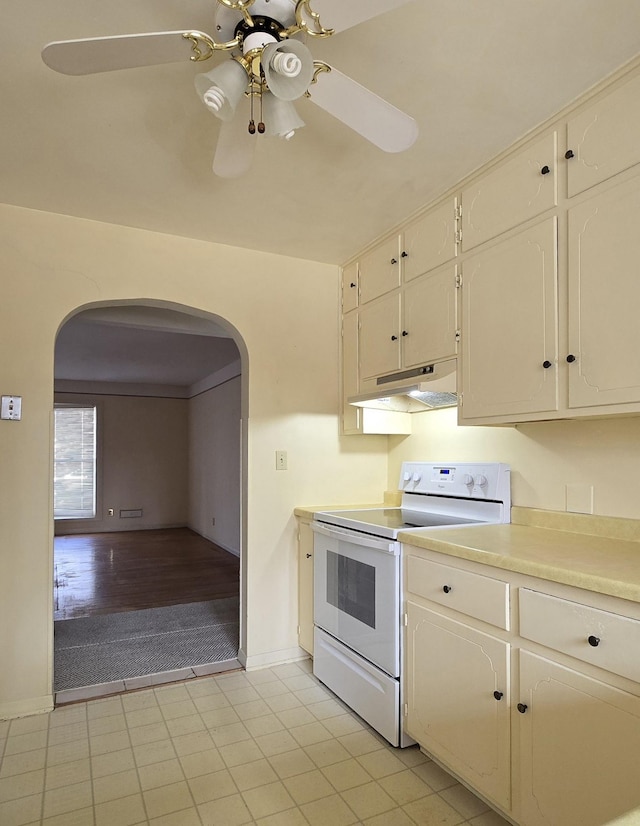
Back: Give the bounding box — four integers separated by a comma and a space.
309, 67, 418, 152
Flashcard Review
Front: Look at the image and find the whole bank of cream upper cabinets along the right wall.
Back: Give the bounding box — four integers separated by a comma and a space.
343, 59, 640, 424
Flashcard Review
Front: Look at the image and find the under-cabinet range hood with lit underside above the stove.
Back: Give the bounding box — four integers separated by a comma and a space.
347, 359, 458, 413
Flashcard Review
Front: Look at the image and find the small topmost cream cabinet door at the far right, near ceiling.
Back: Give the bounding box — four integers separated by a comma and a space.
567, 72, 640, 197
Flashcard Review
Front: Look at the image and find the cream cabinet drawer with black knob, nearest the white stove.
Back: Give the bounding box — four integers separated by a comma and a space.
406, 555, 509, 631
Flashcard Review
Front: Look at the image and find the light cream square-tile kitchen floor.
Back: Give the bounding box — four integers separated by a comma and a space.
0, 661, 507, 826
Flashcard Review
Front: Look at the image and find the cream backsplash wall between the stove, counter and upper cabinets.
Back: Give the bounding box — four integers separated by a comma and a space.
388, 408, 640, 519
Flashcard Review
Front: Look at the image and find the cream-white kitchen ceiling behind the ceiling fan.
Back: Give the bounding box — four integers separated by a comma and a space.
0, 0, 640, 263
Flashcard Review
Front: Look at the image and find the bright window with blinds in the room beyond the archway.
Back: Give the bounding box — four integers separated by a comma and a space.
53, 405, 96, 519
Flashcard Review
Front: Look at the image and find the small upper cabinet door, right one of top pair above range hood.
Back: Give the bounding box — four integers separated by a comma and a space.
401, 198, 456, 283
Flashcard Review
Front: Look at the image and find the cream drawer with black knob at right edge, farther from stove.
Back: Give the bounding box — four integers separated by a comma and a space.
520, 588, 640, 680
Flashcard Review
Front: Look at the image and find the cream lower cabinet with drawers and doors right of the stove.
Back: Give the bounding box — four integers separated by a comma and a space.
403, 546, 640, 826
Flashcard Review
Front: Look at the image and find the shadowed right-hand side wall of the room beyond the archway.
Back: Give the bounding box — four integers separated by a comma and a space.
189, 376, 242, 555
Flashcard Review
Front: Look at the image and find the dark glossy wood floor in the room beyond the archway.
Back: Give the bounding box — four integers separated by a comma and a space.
54, 528, 240, 620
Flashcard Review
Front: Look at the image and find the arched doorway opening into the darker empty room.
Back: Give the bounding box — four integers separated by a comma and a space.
54, 300, 246, 702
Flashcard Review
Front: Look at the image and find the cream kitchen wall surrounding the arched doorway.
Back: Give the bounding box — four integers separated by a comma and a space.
0, 205, 387, 717
